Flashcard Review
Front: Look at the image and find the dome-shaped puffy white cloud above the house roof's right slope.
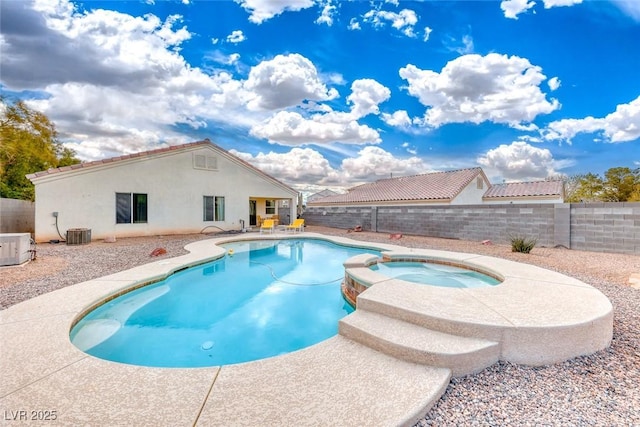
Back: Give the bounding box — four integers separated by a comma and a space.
244, 54, 338, 110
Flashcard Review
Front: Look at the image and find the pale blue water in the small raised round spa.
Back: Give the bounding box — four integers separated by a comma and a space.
369, 262, 500, 288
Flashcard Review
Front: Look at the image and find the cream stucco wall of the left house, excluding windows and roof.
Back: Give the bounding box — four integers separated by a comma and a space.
31, 147, 296, 241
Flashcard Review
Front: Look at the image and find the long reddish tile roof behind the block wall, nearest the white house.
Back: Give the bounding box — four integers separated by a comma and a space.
310, 168, 489, 205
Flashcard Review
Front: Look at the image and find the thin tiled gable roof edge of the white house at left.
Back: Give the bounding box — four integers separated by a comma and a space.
27, 139, 297, 194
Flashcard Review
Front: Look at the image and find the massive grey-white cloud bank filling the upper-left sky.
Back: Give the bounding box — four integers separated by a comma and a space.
3, 0, 390, 160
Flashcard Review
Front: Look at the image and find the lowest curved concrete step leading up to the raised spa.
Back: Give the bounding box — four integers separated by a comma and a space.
338, 309, 500, 377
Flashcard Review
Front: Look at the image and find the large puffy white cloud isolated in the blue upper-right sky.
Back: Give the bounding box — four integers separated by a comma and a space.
400, 53, 559, 127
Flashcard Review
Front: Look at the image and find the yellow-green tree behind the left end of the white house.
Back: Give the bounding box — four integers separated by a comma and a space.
0, 97, 80, 200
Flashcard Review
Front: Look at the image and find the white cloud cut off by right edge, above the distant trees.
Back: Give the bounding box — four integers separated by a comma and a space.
543, 96, 640, 143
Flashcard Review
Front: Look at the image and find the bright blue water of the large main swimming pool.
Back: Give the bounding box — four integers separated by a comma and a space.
71, 239, 378, 367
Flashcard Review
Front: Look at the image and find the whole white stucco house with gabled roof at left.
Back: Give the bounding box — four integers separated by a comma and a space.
27, 139, 299, 242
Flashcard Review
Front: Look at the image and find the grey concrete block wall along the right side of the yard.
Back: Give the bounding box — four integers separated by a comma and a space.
303, 203, 640, 254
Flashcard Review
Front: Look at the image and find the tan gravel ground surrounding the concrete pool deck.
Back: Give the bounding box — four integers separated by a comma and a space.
0, 227, 640, 426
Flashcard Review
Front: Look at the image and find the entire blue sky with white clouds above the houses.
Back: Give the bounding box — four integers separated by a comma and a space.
0, 0, 640, 194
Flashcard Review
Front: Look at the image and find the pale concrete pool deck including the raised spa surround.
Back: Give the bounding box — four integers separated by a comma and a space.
0, 233, 612, 426
